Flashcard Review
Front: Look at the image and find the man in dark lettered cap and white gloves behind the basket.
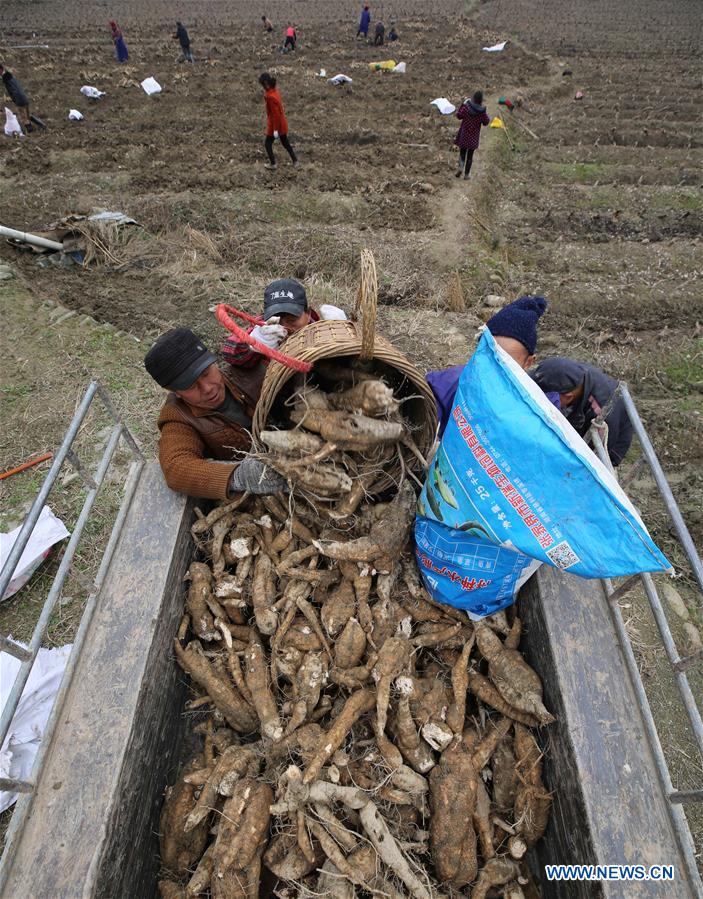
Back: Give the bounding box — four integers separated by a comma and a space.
222, 278, 346, 392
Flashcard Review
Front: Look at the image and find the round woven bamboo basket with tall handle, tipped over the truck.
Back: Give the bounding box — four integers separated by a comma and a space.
252, 250, 437, 489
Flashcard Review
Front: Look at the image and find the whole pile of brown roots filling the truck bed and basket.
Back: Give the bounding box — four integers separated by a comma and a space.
159, 370, 553, 899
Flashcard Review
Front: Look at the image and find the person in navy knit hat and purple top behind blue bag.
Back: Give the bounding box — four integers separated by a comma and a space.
427, 296, 547, 437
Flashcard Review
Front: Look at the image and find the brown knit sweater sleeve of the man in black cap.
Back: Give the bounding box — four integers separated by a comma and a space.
159, 409, 237, 499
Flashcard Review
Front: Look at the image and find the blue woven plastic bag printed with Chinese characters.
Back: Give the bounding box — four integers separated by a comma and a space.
415, 329, 671, 617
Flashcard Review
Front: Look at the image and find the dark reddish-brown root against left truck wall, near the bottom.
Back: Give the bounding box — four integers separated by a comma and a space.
159, 757, 207, 876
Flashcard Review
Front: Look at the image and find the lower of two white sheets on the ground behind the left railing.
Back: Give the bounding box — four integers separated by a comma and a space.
0, 644, 71, 812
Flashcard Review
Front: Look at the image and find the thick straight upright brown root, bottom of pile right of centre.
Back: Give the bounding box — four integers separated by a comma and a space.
430, 739, 478, 889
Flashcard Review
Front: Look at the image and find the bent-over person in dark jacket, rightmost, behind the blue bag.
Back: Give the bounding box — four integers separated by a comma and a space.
532, 356, 632, 467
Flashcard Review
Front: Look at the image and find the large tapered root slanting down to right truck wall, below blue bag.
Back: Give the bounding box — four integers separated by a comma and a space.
476, 626, 555, 724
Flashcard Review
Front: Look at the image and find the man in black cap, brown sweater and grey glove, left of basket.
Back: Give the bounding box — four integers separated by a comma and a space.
144, 328, 286, 499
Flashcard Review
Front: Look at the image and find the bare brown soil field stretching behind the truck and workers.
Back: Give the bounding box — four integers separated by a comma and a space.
0, 0, 703, 884
